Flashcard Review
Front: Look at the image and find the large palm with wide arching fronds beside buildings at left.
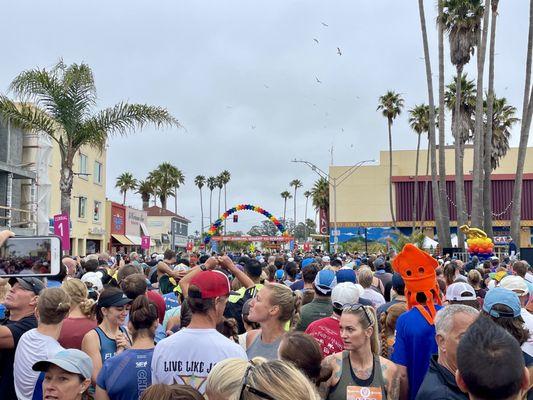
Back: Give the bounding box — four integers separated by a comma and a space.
0, 61, 179, 215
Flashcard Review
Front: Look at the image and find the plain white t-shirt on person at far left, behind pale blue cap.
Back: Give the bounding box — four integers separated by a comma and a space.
13, 328, 64, 400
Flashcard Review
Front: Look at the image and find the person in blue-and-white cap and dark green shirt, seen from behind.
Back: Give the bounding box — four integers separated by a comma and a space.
296, 269, 337, 331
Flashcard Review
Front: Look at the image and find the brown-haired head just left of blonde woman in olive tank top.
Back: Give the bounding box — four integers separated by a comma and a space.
279, 332, 333, 389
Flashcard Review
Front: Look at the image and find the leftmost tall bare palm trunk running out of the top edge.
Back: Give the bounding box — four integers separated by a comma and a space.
418, 0, 442, 247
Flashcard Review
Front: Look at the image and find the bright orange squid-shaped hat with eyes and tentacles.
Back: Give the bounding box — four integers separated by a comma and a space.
392, 243, 442, 325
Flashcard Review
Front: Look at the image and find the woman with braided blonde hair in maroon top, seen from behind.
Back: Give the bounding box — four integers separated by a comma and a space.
58, 278, 98, 350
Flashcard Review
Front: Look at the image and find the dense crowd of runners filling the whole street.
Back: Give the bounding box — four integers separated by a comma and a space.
0, 231, 533, 400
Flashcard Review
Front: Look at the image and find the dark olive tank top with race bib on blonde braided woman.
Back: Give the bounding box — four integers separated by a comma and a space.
326, 351, 387, 400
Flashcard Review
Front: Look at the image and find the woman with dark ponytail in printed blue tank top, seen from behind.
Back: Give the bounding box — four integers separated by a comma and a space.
96, 294, 159, 400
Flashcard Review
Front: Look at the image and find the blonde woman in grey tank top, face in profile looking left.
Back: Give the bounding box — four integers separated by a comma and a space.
246, 283, 300, 360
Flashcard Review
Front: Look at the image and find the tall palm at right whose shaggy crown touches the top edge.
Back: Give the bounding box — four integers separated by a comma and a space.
442, 0, 483, 248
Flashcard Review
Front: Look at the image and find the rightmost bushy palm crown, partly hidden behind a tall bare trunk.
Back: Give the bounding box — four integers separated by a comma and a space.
484, 97, 520, 171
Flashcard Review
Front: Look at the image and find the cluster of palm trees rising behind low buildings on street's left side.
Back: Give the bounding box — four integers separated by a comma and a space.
115, 162, 185, 213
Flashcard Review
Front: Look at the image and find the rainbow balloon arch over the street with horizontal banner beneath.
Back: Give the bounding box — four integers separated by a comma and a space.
204, 204, 294, 247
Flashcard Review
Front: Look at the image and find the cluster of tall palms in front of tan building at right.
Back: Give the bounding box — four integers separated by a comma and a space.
388, 0, 533, 247
